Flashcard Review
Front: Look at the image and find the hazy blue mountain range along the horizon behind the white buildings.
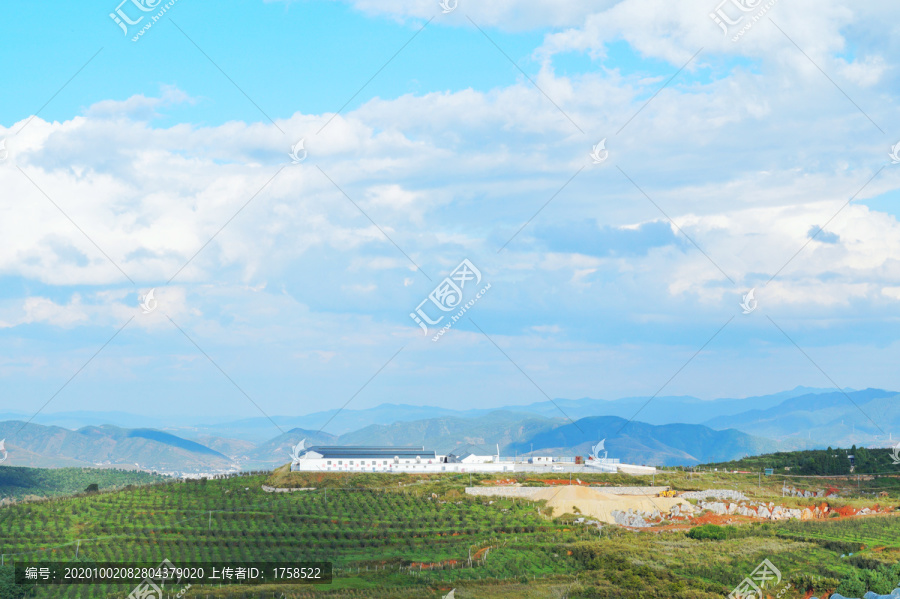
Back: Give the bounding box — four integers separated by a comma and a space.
0, 387, 900, 472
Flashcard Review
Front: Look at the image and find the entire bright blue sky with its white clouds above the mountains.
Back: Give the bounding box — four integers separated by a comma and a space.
0, 0, 900, 432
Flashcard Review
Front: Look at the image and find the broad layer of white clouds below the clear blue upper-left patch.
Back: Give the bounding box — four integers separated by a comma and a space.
0, 0, 900, 420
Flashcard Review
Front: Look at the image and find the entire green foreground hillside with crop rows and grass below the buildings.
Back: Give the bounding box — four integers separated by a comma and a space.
0, 469, 900, 599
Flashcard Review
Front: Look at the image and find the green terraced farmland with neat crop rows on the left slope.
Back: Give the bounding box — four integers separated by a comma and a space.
0, 476, 590, 597
